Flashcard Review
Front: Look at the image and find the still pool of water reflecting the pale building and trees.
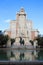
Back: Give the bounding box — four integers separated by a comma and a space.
0, 50, 43, 61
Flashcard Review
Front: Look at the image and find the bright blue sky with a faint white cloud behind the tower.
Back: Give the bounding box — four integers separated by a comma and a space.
0, 0, 43, 34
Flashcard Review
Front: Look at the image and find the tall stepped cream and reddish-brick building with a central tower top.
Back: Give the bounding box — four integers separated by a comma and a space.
6, 8, 38, 43
